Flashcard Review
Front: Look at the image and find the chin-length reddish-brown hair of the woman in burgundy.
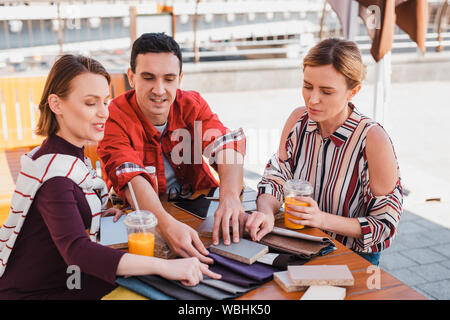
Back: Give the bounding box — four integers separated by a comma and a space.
36, 54, 111, 136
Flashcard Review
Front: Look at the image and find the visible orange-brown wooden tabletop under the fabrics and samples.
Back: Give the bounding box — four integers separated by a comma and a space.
103, 192, 427, 300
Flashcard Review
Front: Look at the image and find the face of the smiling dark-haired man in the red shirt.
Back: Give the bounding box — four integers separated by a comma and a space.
127, 52, 183, 125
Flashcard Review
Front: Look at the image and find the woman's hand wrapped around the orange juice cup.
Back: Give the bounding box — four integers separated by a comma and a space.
286, 197, 328, 229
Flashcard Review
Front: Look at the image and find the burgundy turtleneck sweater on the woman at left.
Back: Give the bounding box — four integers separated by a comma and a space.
0, 135, 125, 299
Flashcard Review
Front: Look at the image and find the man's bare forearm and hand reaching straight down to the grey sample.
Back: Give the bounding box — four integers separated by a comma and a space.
213, 149, 245, 245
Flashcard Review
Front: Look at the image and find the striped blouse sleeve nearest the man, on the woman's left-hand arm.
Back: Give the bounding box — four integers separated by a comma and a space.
258, 125, 298, 202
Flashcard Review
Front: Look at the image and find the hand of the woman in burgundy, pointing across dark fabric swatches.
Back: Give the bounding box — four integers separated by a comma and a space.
158, 257, 222, 286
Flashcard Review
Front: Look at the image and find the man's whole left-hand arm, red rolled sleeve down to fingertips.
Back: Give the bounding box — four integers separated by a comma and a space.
97, 105, 213, 263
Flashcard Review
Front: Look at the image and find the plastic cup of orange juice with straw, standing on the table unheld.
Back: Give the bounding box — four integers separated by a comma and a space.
124, 210, 158, 257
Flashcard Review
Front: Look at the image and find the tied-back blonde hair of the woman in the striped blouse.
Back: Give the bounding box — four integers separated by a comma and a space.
303, 38, 366, 89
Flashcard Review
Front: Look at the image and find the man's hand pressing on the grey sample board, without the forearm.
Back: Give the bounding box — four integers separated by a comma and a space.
213, 196, 245, 245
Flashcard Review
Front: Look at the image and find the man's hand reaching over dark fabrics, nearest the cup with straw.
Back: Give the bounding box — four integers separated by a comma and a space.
158, 218, 214, 264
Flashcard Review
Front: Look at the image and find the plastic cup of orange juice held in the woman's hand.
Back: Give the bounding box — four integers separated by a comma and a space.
283, 179, 313, 229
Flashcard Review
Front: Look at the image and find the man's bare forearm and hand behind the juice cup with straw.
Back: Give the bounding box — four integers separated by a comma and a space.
124, 175, 213, 263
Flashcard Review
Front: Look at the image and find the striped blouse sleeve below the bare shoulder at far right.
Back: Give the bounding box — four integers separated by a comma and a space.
356, 145, 403, 252
